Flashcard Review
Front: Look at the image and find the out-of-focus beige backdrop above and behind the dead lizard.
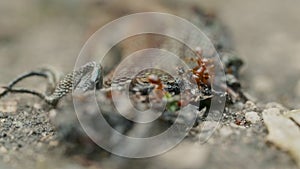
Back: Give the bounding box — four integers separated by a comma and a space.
0, 0, 300, 108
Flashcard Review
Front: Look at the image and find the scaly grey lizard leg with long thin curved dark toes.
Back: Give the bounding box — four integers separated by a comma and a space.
0, 62, 103, 106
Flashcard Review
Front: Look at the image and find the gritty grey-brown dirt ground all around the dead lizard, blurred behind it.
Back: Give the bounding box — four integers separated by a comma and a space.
0, 0, 300, 169
